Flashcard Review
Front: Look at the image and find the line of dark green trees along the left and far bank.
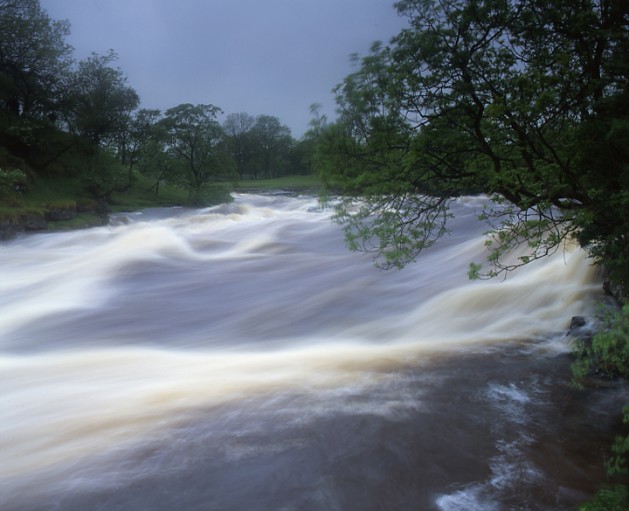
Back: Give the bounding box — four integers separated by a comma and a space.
0, 0, 313, 203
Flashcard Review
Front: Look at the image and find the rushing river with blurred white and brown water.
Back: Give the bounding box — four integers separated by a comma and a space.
0, 195, 623, 511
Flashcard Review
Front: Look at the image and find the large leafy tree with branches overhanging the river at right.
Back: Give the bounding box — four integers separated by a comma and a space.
318, 0, 629, 289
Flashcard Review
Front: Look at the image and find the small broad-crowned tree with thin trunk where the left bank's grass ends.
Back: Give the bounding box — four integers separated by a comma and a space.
162, 103, 234, 201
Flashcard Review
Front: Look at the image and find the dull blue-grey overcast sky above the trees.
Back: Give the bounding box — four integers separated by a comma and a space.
40, 0, 405, 138
